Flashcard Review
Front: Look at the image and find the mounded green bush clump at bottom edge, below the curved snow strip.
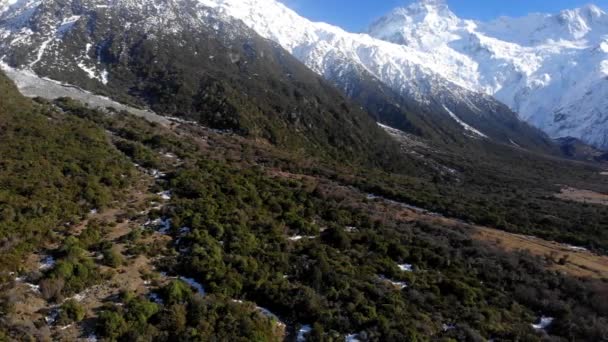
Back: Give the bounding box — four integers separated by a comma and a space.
97, 280, 281, 342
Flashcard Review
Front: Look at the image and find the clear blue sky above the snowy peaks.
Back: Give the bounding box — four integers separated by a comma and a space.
280, 0, 608, 32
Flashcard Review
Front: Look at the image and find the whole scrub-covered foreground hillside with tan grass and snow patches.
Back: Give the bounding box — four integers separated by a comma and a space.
0, 71, 608, 341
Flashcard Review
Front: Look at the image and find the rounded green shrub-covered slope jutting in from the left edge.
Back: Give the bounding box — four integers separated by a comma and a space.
0, 67, 133, 270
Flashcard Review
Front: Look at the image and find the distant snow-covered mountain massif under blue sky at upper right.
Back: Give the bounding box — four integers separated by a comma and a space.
368, 0, 608, 148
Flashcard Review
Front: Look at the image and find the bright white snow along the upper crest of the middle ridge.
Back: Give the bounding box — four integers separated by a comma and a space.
199, 0, 456, 105
